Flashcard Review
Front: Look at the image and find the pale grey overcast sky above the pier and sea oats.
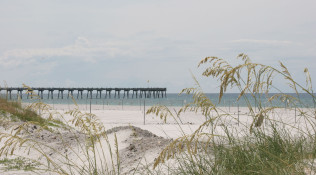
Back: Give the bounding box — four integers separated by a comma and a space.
0, 0, 316, 93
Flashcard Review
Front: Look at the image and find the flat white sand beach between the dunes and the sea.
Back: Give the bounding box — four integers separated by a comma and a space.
49, 105, 311, 139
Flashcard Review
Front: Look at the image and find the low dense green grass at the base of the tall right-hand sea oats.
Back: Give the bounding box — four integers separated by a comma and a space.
173, 124, 316, 175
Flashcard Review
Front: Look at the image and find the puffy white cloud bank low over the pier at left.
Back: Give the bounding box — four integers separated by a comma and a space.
0, 37, 124, 66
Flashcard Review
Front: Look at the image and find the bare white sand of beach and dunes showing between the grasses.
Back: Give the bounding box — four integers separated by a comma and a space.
0, 105, 310, 174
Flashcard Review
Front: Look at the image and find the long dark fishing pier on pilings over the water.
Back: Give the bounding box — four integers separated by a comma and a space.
0, 87, 167, 99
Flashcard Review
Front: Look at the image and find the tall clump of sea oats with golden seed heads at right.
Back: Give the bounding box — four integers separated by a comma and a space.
147, 54, 316, 174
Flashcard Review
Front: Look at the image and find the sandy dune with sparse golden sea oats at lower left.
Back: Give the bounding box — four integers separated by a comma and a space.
0, 86, 120, 175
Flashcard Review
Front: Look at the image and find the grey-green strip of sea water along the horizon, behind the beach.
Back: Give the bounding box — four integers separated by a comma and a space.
0, 91, 315, 108
